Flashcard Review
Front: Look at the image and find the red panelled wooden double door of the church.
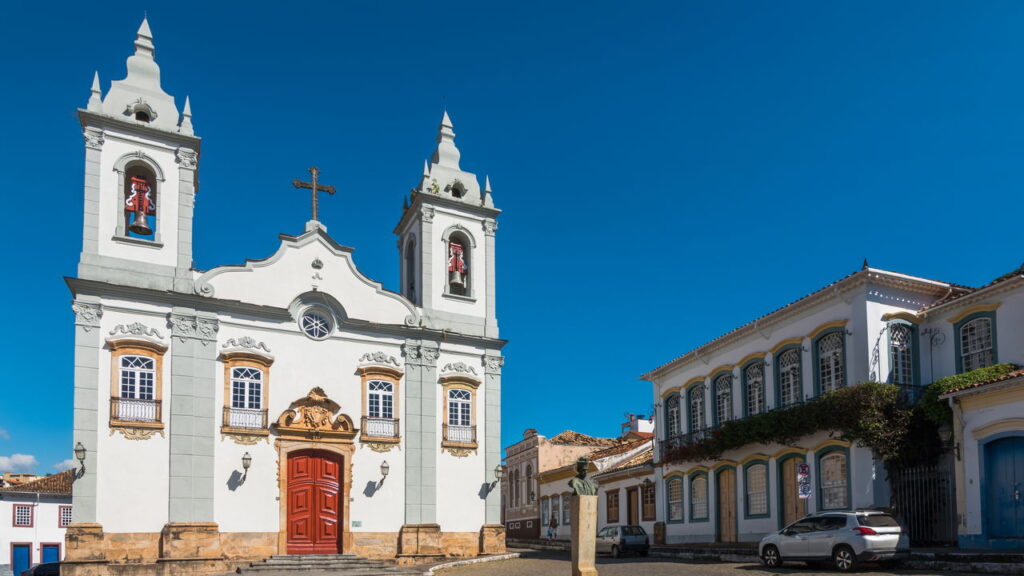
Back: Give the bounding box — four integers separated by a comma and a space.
288, 450, 342, 554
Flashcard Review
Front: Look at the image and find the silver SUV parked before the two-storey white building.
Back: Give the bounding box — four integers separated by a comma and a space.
758, 510, 910, 572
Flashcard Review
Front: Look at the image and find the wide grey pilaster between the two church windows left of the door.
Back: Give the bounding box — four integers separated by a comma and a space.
164, 307, 219, 524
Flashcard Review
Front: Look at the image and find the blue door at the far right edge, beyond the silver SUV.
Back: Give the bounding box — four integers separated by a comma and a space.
985, 437, 1024, 538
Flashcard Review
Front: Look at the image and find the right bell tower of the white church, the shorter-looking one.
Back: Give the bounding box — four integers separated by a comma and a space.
394, 112, 501, 338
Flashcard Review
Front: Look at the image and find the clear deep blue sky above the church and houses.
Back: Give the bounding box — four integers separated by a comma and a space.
0, 0, 1024, 472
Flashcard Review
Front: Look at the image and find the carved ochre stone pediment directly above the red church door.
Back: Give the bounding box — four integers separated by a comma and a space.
272, 386, 358, 444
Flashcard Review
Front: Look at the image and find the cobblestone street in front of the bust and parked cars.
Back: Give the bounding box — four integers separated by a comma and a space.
437, 551, 983, 576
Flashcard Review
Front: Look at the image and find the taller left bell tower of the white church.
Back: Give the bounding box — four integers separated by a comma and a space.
78, 19, 200, 292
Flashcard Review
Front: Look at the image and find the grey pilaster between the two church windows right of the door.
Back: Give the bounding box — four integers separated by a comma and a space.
402, 340, 440, 525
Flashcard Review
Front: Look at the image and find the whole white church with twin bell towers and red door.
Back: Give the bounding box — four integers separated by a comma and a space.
66, 17, 505, 574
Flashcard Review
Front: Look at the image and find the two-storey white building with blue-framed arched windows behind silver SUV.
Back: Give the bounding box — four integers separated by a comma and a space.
642, 262, 1021, 543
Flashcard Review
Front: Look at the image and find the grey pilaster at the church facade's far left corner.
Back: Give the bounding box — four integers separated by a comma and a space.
67, 298, 103, 523
